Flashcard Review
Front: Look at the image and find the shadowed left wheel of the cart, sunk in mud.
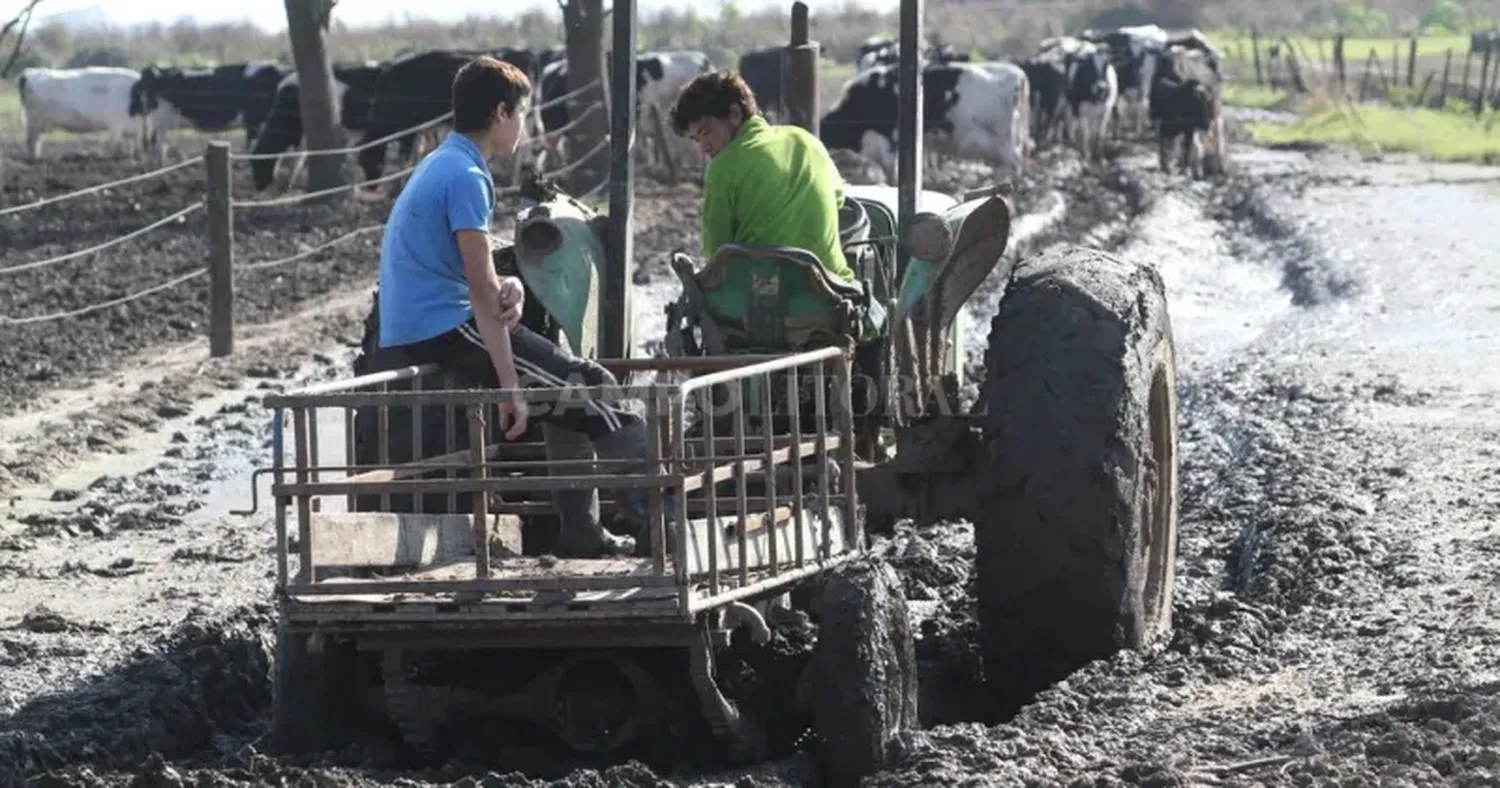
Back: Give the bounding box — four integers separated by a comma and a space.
270, 627, 356, 755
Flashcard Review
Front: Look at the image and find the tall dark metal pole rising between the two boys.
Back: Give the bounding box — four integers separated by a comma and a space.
599, 0, 636, 359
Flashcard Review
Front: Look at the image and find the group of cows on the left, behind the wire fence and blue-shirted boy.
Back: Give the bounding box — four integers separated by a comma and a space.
17, 47, 711, 191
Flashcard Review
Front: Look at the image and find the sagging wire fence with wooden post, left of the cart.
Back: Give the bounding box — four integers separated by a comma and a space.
0, 81, 621, 337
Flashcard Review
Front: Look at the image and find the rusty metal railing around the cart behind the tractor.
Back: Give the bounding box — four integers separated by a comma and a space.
266, 348, 864, 617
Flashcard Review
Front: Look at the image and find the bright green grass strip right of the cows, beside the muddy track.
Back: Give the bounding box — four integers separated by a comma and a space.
1248, 104, 1500, 164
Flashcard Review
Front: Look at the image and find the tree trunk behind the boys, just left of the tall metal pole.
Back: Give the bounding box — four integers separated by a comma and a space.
563, 0, 609, 195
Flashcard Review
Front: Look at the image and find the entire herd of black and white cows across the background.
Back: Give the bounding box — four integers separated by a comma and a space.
18, 26, 1224, 198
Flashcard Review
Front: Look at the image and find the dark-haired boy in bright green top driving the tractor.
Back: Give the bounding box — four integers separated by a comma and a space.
672, 71, 854, 282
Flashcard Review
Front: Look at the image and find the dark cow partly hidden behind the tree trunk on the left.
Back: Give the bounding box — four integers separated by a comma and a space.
251, 62, 381, 191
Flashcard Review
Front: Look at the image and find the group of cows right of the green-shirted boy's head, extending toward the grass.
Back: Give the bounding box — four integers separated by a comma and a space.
740, 26, 1224, 182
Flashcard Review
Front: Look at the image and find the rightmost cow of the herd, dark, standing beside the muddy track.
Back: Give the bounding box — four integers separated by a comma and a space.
1151, 47, 1226, 177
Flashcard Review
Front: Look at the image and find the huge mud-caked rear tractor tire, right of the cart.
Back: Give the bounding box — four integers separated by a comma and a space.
975, 248, 1179, 714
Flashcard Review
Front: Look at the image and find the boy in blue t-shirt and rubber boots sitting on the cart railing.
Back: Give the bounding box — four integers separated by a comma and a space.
380, 57, 650, 557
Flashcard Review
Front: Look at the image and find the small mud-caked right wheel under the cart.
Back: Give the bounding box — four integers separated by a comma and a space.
801, 558, 920, 788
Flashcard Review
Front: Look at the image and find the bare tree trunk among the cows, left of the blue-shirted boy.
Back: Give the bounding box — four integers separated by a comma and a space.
285, 0, 345, 192
